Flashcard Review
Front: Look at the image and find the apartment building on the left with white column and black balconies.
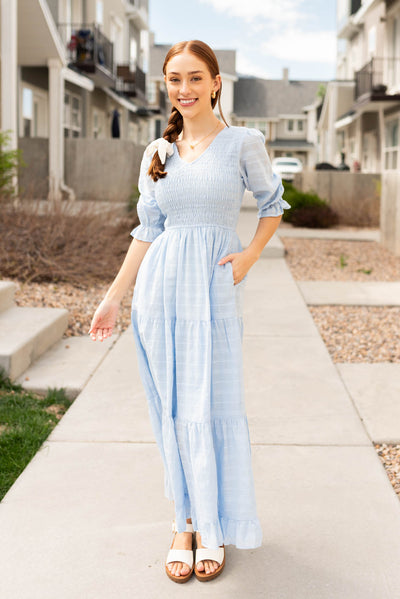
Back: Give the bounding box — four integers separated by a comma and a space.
0, 0, 149, 199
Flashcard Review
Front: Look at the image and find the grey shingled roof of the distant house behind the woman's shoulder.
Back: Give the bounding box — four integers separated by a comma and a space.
233, 77, 327, 118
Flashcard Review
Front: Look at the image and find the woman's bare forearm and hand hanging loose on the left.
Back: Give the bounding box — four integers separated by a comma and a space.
89, 238, 152, 341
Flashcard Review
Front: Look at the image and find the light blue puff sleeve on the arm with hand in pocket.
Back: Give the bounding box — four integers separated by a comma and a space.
240, 128, 291, 218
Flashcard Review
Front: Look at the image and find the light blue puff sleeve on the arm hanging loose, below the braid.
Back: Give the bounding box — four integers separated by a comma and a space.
130, 151, 166, 241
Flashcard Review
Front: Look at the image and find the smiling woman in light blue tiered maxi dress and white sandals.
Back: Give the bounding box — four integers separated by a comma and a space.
89, 40, 290, 582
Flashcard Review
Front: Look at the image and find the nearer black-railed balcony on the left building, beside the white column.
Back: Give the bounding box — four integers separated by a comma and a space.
58, 23, 116, 87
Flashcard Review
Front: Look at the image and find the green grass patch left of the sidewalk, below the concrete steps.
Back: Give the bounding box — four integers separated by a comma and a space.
0, 371, 72, 501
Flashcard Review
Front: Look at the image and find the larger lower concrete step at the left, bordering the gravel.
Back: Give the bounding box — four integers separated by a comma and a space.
0, 307, 68, 380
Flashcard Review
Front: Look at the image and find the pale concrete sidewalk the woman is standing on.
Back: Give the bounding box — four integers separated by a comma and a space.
0, 214, 400, 599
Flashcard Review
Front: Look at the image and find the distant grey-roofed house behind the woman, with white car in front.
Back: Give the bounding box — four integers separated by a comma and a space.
233, 68, 326, 168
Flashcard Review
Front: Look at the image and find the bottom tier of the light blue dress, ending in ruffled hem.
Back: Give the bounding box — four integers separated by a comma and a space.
150, 405, 262, 549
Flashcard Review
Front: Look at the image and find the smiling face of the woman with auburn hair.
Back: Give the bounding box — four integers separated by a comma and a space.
164, 51, 221, 118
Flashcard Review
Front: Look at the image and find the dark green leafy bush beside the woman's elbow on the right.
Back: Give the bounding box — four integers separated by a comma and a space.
282, 182, 339, 228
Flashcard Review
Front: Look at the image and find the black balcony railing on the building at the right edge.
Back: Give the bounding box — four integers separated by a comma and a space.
355, 58, 400, 98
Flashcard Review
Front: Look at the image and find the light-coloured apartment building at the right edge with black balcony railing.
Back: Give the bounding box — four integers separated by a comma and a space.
319, 0, 400, 173
